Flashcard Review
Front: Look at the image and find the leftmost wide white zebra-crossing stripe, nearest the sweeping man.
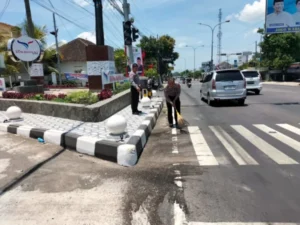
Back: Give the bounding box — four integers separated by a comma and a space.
188, 127, 219, 166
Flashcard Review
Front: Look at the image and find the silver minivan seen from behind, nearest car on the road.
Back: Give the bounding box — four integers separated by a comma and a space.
200, 69, 247, 105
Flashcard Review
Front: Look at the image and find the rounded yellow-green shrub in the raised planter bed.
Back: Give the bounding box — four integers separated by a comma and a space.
65, 91, 98, 105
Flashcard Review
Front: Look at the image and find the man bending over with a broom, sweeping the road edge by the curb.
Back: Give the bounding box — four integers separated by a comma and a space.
165, 77, 181, 127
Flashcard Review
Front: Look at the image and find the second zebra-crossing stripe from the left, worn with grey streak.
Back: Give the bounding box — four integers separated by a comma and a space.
209, 126, 258, 165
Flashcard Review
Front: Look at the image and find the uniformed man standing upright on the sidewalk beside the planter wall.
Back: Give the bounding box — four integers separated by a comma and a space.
129, 63, 142, 115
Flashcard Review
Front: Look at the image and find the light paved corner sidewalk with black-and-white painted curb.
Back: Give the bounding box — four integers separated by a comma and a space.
0, 93, 163, 166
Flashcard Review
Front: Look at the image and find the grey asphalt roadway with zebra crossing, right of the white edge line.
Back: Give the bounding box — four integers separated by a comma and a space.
178, 82, 300, 224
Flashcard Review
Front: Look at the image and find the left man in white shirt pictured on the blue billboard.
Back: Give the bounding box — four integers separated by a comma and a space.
266, 0, 295, 28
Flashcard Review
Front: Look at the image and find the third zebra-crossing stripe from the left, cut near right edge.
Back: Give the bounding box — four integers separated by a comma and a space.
231, 125, 298, 165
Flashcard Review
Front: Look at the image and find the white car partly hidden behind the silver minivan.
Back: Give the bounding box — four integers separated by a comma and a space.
241, 70, 263, 95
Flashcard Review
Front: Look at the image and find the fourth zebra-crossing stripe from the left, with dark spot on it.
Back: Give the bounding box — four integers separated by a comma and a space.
254, 124, 300, 152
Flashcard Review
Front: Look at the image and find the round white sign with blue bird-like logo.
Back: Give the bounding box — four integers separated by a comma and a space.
11, 36, 41, 62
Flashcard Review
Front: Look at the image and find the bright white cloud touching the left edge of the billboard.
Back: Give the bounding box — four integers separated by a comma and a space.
231, 0, 266, 23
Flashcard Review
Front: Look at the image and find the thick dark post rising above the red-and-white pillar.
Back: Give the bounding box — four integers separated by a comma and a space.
94, 0, 104, 46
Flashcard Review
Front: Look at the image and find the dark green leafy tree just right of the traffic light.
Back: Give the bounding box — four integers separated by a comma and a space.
139, 35, 179, 75
